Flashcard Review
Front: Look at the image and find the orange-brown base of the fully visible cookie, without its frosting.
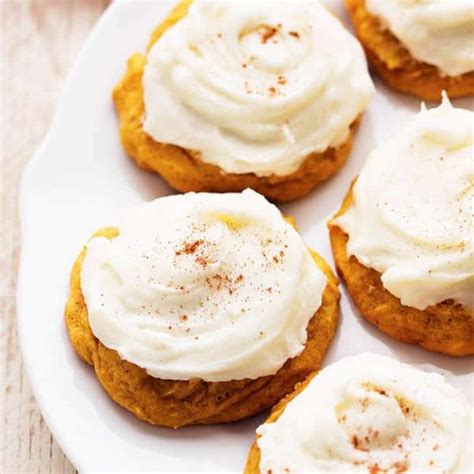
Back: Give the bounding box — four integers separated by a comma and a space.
65, 228, 340, 428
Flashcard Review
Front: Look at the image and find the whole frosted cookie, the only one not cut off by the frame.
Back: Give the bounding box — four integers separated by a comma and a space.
66, 190, 339, 428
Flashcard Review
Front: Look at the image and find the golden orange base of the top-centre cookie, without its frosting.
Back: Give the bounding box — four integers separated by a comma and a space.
113, 0, 359, 202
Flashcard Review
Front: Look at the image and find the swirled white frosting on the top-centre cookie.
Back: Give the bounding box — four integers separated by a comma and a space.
143, 0, 374, 176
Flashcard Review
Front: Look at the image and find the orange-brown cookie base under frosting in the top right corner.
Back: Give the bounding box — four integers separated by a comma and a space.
345, 0, 474, 101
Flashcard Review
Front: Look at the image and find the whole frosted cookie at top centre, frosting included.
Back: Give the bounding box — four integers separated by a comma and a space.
113, 0, 374, 201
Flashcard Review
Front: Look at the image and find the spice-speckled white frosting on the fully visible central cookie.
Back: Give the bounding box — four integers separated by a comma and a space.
81, 190, 327, 381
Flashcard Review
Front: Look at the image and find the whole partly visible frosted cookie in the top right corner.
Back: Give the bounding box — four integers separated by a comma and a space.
346, 0, 474, 100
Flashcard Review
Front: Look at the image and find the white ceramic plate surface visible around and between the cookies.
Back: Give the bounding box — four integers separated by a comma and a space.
18, 0, 473, 472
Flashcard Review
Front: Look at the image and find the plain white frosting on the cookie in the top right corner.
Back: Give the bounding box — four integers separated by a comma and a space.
365, 0, 474, 76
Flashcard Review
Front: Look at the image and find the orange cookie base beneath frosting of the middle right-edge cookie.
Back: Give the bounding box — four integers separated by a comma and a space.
329, 190, 474, 356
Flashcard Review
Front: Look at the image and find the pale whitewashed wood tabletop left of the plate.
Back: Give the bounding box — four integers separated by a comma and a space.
0, 0, 109, 474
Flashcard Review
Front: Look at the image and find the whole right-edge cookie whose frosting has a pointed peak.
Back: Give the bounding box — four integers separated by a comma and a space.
329, 97, 474, 356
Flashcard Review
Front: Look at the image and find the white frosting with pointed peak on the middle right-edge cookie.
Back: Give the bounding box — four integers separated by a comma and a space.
331, 95, 474, 310
